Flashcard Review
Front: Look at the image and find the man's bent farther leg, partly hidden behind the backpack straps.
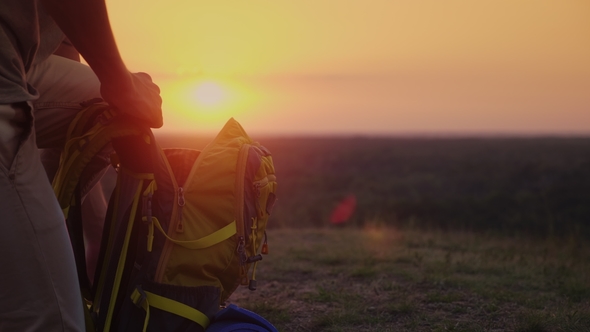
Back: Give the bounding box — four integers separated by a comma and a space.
27, 56, 116, 281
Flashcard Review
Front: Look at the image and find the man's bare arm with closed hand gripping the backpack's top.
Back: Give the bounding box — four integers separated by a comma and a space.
40, 0, 162, 128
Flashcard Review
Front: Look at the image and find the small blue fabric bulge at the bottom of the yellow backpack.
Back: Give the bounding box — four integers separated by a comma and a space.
206, 304, 278, 332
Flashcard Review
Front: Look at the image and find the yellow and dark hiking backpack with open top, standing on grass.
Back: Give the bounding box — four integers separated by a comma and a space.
54, 103, 277, 331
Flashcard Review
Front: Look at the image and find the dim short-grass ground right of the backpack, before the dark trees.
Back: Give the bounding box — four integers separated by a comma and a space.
230, 225, 590, 332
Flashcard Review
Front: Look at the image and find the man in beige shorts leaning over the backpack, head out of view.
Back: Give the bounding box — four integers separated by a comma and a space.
0, 0, 162, 331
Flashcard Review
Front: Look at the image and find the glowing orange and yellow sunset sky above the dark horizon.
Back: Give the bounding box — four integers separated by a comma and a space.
107, 0, 590, 135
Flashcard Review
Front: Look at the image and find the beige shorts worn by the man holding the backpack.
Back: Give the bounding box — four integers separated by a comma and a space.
0, 56, 104, 331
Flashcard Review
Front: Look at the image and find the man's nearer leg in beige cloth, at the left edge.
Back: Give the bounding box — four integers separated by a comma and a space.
0, 103, 84, 331
